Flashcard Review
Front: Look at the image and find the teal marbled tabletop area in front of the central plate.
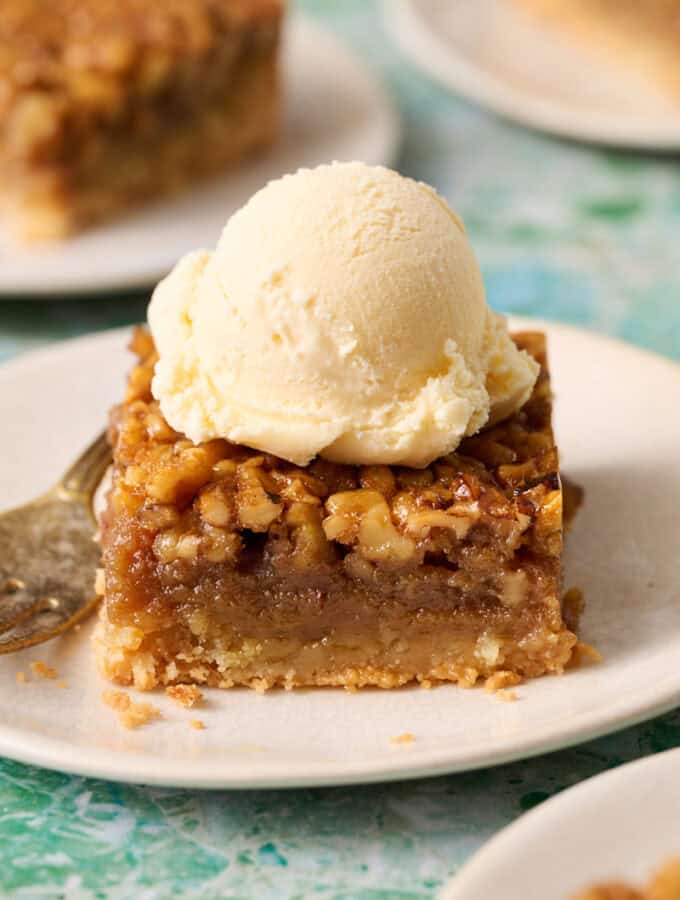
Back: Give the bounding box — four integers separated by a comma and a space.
0, 711, 680, 900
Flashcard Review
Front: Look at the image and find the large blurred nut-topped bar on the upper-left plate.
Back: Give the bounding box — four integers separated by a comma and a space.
0, 0, 281, 239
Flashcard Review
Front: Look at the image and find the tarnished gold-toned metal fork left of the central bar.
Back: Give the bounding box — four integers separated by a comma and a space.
0, 432, 111, 653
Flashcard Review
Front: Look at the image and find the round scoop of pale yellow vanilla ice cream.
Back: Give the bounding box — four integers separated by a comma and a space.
149, 163, 538, 467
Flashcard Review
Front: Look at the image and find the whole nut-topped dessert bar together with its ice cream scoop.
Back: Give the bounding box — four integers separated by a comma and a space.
95, 163, 576, 689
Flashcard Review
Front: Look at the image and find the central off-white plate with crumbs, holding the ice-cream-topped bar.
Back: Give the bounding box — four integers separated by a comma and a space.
0, 320, 680, 787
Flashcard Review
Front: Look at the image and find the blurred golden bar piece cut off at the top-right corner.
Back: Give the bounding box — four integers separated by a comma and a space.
513, 0, 680, 98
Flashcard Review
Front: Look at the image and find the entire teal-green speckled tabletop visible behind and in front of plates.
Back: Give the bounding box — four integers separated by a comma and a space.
0, 0, 680, 900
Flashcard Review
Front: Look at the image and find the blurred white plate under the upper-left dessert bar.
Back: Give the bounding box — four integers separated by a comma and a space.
0, 16, 399, 297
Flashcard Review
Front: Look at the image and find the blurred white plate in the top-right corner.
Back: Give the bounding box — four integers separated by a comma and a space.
383, 0, 680, 151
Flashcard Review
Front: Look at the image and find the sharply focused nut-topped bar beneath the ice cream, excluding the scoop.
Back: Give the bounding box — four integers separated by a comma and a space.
95, 330, 576, 689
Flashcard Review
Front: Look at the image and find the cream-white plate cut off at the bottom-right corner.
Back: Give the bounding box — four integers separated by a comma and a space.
439, 750, 680, 900
